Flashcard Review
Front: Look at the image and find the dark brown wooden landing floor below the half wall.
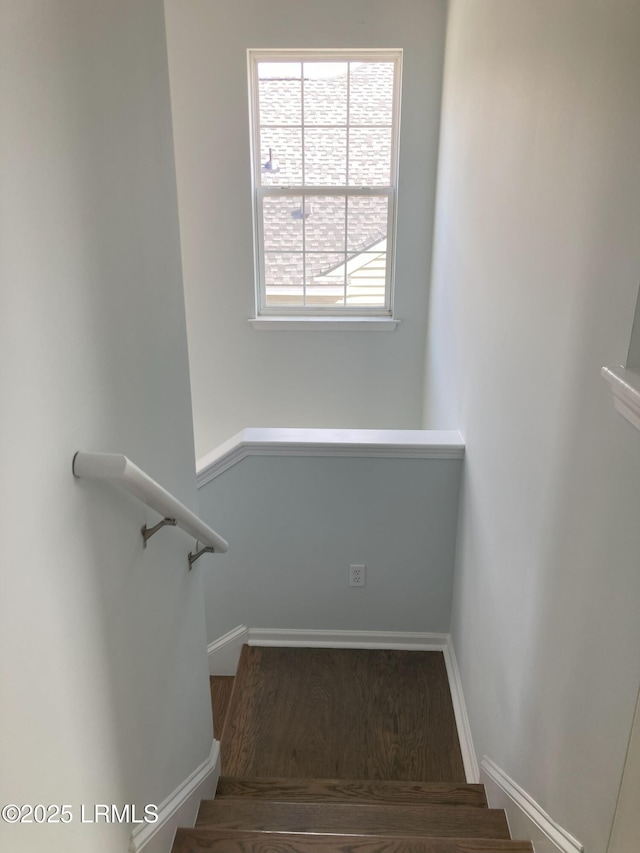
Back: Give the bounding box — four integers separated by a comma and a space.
222, 646, 465, 783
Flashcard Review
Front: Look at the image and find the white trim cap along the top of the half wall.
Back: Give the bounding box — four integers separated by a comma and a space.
196, 427, 464, 489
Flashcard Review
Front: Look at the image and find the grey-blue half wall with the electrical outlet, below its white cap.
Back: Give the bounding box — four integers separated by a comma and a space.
199, 456, 462, 642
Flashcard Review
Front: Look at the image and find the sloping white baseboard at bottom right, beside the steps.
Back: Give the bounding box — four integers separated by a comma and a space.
480, 755, 584, 853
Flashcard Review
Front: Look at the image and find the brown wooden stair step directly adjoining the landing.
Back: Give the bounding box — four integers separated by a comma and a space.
216, 776, 487, 808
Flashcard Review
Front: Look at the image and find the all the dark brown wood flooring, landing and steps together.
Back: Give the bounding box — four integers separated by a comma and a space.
173, 646, 533, 853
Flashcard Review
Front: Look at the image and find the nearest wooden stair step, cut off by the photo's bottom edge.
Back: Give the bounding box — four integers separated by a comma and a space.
173, 828, 533, 853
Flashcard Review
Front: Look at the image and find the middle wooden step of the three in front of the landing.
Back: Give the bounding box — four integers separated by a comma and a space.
196, 797, 510, 839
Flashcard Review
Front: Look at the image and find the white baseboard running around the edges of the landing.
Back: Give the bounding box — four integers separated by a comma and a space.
208, 625, 479, 782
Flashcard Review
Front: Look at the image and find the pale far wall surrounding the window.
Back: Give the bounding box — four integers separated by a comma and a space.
165, 0, 446, 457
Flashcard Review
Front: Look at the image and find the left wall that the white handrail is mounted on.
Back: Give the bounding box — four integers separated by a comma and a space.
0, 0, 212, 853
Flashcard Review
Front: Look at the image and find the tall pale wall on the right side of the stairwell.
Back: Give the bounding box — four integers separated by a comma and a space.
425, 0, 640, 852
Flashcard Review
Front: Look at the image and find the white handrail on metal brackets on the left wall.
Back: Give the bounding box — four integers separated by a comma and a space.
73, 450, 229, 554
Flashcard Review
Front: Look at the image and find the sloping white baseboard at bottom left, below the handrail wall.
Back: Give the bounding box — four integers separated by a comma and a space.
129, 740, 220, 853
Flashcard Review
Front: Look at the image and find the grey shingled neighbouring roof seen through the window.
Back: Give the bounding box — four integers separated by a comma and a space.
258, 61, 394, 296
